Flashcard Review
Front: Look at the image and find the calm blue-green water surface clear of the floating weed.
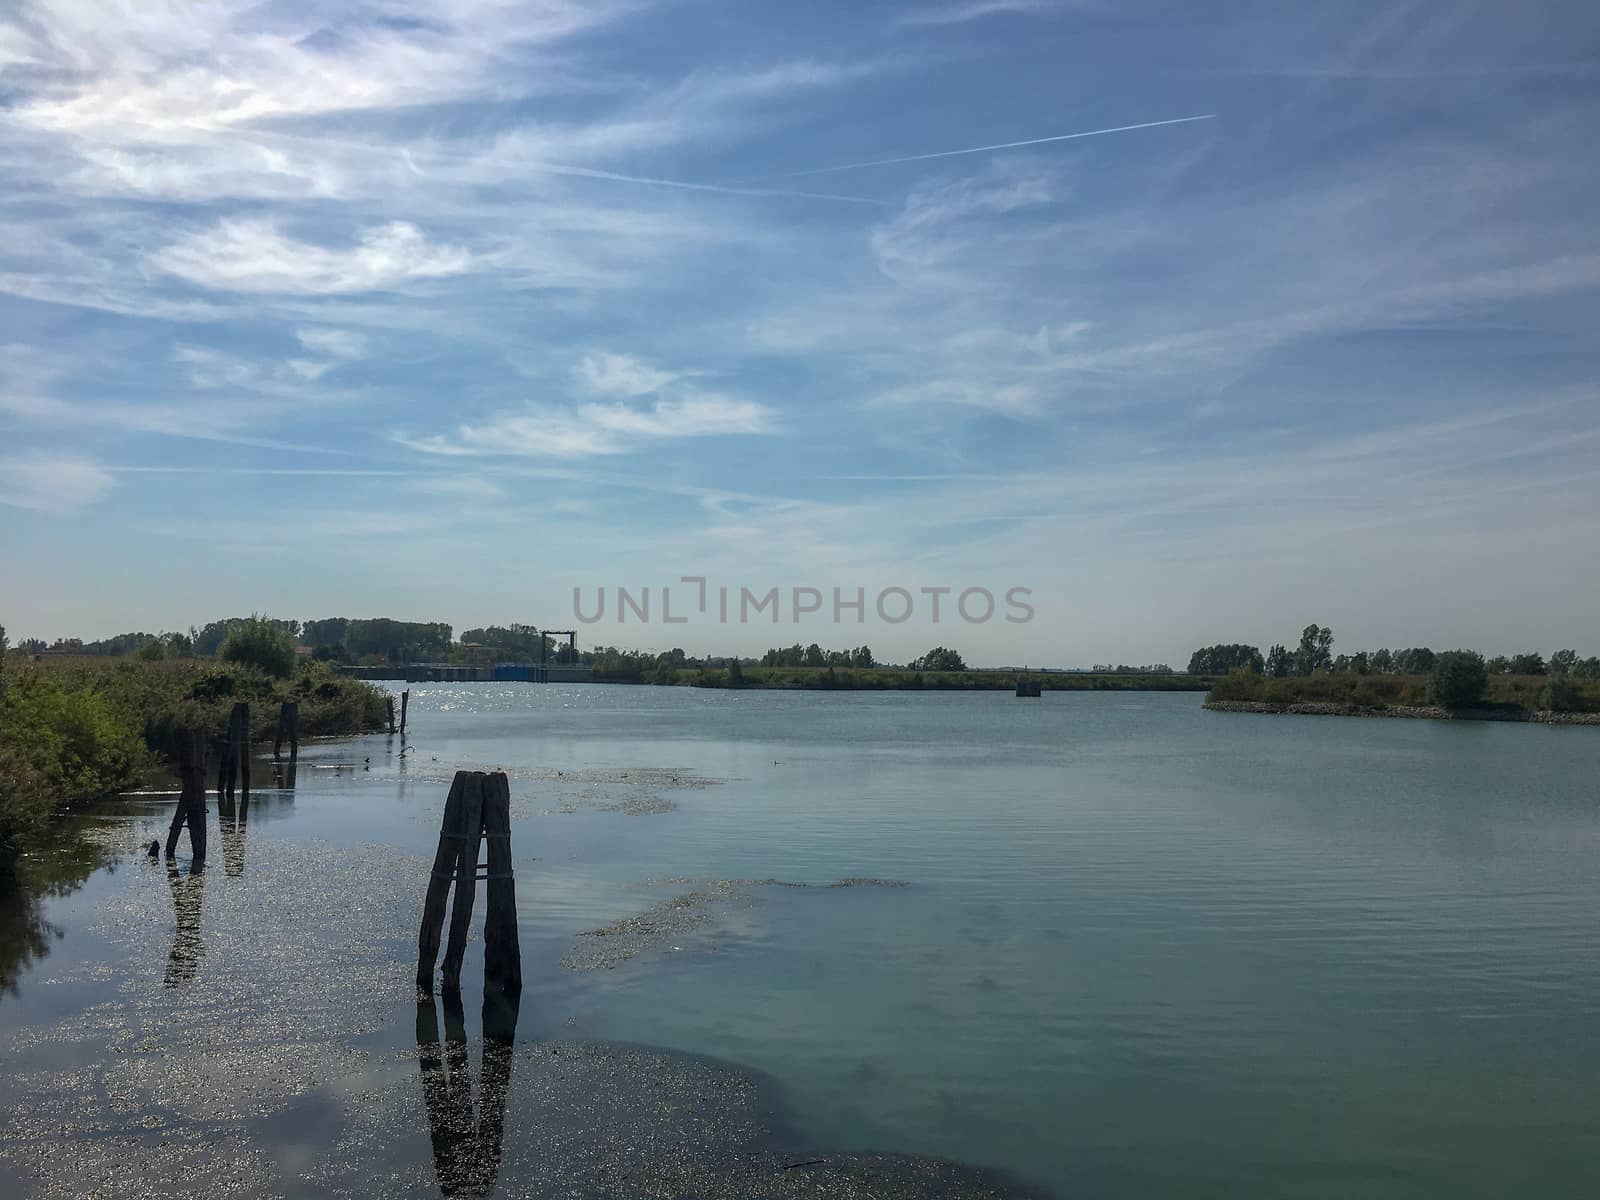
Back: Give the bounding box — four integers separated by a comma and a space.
0, 683, 1600, 1198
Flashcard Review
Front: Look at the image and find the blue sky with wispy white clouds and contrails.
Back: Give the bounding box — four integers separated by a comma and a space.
0, 0, 1600, 667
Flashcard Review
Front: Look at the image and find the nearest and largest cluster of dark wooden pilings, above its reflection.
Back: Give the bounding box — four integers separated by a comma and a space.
416, 771, 522, 995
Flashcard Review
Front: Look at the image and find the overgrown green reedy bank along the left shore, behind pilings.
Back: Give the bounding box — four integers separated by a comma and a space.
0, 654, 387, 885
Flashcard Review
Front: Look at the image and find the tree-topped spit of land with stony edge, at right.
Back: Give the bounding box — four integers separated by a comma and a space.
1189, 624, 1600, 725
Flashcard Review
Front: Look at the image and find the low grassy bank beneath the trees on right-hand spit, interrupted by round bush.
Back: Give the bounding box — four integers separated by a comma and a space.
1206, 670, 1600, 714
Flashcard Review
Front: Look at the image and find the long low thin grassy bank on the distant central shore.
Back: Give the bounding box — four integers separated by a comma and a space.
659, 667, 1214, 691
